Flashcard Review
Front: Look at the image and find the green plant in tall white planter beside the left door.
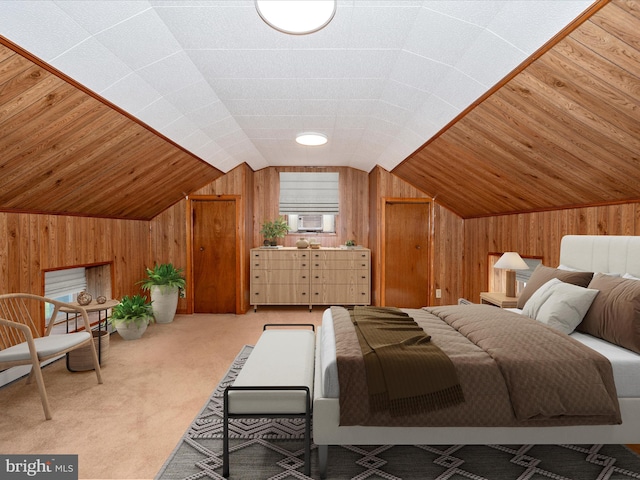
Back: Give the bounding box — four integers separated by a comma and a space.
138, 263, 186, 323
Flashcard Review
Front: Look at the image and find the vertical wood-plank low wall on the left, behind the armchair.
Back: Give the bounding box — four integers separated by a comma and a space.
0, 212, 150, 330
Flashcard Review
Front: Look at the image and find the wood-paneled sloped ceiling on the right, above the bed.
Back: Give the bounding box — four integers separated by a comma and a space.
393, 0, 640, 218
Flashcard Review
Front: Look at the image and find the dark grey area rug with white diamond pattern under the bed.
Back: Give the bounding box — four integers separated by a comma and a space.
156, 346, 640, 480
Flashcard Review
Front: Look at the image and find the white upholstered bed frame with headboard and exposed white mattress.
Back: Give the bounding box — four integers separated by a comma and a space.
313, 235, 640, 475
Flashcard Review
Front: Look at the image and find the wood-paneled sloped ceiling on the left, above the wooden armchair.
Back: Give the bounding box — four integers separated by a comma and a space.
0, 39, 222, 219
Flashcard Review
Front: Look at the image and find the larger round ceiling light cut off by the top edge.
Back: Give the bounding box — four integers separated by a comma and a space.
255, 0, 336, 35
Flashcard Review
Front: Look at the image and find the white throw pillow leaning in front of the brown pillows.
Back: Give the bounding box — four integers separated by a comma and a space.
522, 278, 598, 334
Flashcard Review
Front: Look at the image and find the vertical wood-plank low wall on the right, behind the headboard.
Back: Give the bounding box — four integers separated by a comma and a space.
462, 203, 640, 302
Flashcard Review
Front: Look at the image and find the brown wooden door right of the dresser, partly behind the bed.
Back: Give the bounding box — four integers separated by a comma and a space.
382, 200, 431, 308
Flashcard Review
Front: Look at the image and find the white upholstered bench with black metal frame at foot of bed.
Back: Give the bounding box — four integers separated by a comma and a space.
222, 324, 315, 477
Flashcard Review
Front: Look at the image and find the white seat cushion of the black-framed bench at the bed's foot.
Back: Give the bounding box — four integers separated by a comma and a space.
229, 329, 315, 414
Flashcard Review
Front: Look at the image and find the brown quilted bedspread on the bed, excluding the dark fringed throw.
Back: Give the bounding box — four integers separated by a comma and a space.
332, 305, 621, 426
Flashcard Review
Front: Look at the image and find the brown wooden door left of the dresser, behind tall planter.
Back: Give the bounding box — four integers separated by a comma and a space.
191, 199, 238, 313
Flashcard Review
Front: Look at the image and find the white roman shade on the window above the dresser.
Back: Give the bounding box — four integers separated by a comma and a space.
280, 172, 339, 215
